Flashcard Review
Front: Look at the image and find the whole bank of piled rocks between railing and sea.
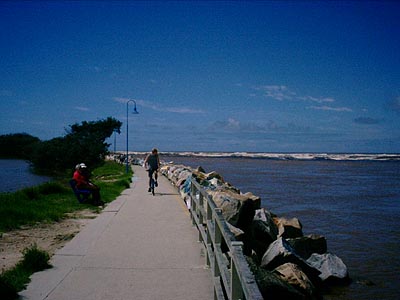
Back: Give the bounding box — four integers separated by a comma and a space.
161, 164, 351, 299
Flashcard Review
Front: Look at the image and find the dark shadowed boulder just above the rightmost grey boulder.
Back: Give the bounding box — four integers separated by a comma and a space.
287, 234, 328, 259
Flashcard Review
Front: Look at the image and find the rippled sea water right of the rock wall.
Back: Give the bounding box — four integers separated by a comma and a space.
162, 156, 400, 300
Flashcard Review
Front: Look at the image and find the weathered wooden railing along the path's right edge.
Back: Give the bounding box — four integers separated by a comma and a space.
190, 177, 263, 300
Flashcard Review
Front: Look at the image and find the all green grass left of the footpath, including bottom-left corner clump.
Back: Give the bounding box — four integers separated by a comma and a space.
0, 162, 132, 299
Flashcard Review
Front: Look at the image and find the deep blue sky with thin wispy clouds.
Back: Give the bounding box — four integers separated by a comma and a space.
0, 0, 400, 153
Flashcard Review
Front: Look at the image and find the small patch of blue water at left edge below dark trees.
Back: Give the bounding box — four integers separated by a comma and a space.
0, 159, 51, 193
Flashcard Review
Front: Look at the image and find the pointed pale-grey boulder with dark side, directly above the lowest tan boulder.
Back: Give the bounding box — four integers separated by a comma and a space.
261, 237, 320, 282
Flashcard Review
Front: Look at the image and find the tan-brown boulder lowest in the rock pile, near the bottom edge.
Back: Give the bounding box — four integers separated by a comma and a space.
273, 263, 318, 299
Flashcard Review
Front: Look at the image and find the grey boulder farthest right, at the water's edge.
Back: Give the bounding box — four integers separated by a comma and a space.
307, 253, 350, 284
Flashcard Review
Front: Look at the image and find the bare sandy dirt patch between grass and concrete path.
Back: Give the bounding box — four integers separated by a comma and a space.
0, 209, 98, 273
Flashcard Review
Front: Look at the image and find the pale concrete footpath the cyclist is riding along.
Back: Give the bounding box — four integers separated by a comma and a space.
20, 166, 213, 300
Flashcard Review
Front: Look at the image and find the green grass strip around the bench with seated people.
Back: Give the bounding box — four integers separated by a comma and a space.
0, 162, 132, 233
